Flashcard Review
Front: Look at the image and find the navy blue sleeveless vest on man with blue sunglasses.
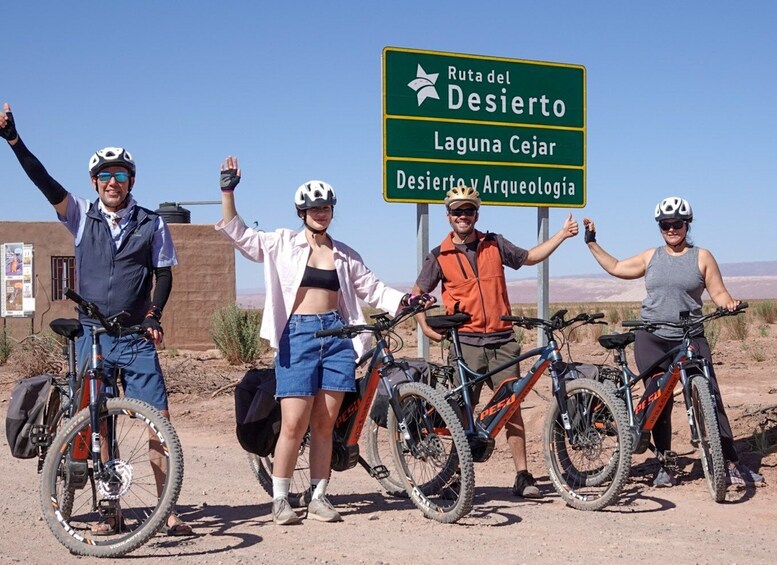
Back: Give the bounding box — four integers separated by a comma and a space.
76, 201, 159, 326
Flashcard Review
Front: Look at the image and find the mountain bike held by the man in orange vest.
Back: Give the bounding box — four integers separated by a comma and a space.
371, 310, 631, 510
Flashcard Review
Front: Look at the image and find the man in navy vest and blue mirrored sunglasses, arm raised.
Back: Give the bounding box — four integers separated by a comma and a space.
0, 103, 192, 535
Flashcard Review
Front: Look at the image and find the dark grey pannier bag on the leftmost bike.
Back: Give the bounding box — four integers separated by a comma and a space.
5, 375, 52, 459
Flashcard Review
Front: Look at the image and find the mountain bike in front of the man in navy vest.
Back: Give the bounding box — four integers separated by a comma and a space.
41, 289, 183, 557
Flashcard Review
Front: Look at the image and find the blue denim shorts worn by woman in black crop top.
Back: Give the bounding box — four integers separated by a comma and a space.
275, 311, 356, 398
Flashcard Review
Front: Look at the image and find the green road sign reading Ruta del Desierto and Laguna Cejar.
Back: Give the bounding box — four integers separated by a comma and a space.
383, 47, 586, 207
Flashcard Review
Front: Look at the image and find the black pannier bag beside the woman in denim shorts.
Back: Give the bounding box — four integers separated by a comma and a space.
235, 369, 281, 457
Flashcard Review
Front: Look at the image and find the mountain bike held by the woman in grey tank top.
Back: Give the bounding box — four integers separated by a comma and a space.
599, 302, 748, 502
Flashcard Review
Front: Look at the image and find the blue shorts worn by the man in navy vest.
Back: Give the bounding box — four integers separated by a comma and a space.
76, 327, 167, 410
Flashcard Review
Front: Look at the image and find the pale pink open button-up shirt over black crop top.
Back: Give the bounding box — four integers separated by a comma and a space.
216, 216, 404, 357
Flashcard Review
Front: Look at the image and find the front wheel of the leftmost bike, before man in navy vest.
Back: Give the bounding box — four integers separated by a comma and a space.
41, 398, 183, 557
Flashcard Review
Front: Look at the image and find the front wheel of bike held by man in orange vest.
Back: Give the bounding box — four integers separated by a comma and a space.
543, 379, 631, 510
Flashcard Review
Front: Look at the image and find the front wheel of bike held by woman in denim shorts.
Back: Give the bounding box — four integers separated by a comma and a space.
387, 383, 475, 523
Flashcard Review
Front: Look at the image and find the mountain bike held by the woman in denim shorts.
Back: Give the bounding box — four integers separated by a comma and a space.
249, 304, 475, 523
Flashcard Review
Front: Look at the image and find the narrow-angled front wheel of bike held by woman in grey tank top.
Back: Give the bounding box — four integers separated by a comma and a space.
690, 375, 726, 502
